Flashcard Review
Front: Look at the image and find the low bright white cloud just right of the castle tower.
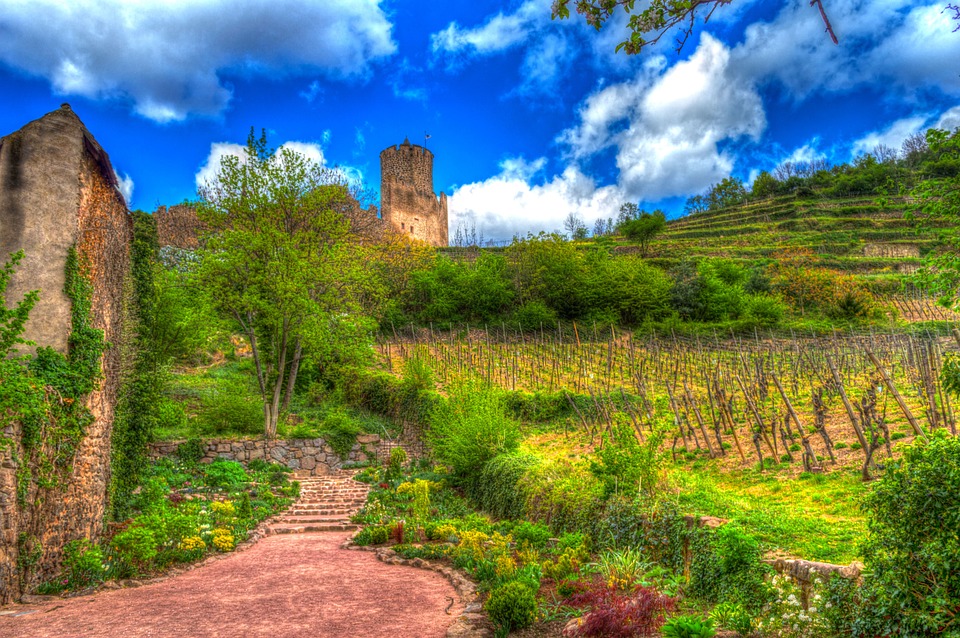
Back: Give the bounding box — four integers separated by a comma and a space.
448, 158, 626, 240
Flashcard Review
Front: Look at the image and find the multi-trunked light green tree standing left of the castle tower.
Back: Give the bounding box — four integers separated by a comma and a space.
198, 130, 370, 438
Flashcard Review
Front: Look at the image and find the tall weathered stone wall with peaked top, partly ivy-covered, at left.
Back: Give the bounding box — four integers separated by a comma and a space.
0, 106, 133, 604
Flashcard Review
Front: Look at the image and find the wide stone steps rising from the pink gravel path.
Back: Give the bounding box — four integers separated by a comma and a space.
268, 470, 370, 534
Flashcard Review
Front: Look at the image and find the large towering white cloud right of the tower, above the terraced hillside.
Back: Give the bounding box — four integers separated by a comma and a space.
560, 34, 766, 201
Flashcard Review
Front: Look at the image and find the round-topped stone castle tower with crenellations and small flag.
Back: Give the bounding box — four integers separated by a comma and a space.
380, 139, 449, 246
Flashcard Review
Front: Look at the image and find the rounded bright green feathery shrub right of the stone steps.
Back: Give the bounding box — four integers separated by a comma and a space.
426, 383, 520, 484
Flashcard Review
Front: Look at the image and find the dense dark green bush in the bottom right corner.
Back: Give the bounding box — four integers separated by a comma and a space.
862, 430, 960, 636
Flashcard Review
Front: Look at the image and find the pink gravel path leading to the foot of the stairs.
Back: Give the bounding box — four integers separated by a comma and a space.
0, 533, 463, 638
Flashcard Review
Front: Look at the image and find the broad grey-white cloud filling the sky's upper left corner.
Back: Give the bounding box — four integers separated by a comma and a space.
0, 0, 396, 122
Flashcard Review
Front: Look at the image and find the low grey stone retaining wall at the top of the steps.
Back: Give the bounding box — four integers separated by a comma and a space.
149, 434, 399, 476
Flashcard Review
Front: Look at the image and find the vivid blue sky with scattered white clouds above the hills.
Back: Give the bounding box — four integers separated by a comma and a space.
0, 0, 960, 239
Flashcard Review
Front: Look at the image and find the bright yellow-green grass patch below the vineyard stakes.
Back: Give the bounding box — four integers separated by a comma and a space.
675, 468, 867, 564
